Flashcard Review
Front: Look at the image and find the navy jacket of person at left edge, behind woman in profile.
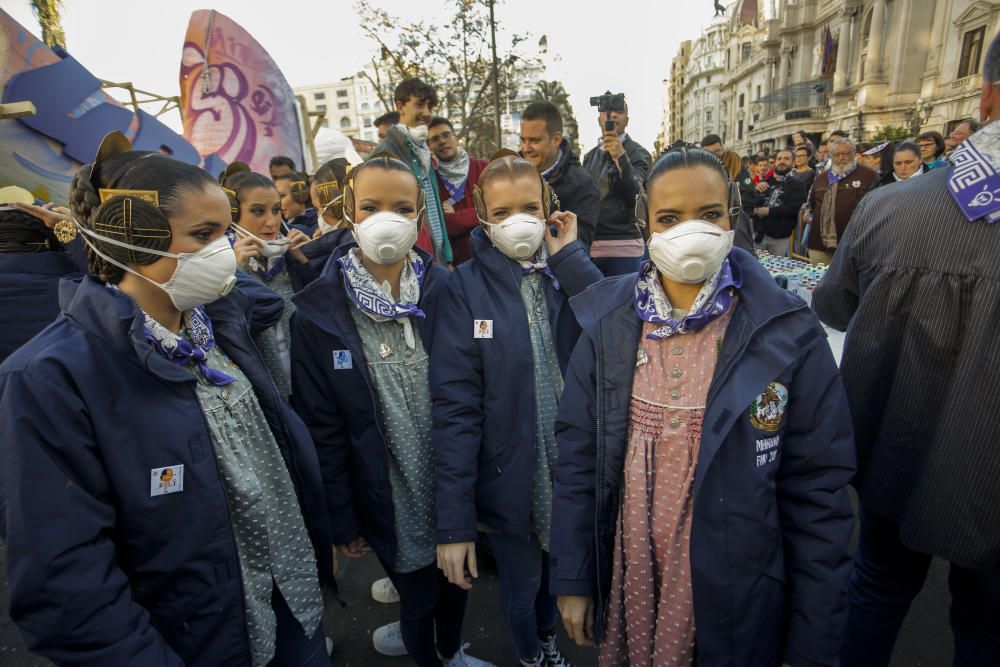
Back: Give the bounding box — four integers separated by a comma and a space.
0, 251, 86, 362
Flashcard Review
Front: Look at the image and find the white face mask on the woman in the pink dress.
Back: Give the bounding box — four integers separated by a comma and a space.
649, 220, 733, 284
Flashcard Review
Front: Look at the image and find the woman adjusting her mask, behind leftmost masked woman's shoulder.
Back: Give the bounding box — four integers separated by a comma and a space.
223, 168, 309, 398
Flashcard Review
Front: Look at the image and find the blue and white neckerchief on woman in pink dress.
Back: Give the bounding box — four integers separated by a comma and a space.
635, 254, 743, 340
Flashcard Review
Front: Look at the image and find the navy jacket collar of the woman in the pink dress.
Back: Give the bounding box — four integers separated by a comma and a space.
571, 248, 804, 336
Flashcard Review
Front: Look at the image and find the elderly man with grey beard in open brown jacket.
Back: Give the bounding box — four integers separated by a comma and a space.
808, 137, 878, 264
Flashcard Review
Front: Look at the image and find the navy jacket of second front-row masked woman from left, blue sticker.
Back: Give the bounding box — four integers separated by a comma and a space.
292, 243, 448, 563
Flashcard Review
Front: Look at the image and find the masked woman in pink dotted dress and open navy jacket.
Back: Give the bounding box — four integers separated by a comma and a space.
552, 149, 854, 666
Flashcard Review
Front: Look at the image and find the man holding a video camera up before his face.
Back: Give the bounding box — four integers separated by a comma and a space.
583, 98, 653, 276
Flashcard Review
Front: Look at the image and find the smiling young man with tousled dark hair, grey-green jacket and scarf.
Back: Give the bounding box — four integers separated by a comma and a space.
371, 78, 453, 264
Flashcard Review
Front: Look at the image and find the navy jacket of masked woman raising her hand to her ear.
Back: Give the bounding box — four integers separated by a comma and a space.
430, 228, 603, 544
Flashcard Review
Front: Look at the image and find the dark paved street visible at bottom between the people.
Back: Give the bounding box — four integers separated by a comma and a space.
0, 500, 952, 667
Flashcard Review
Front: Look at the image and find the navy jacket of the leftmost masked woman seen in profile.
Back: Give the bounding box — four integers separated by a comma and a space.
0, 277, 333, 667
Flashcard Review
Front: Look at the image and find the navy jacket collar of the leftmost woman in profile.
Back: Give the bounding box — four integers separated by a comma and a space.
59, 276, 250, 382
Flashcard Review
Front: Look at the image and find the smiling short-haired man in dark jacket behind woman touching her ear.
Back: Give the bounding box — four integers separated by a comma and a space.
521, 102, 600, 251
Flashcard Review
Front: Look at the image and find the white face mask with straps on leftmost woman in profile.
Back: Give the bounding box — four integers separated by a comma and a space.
77, 223, 236, 312
